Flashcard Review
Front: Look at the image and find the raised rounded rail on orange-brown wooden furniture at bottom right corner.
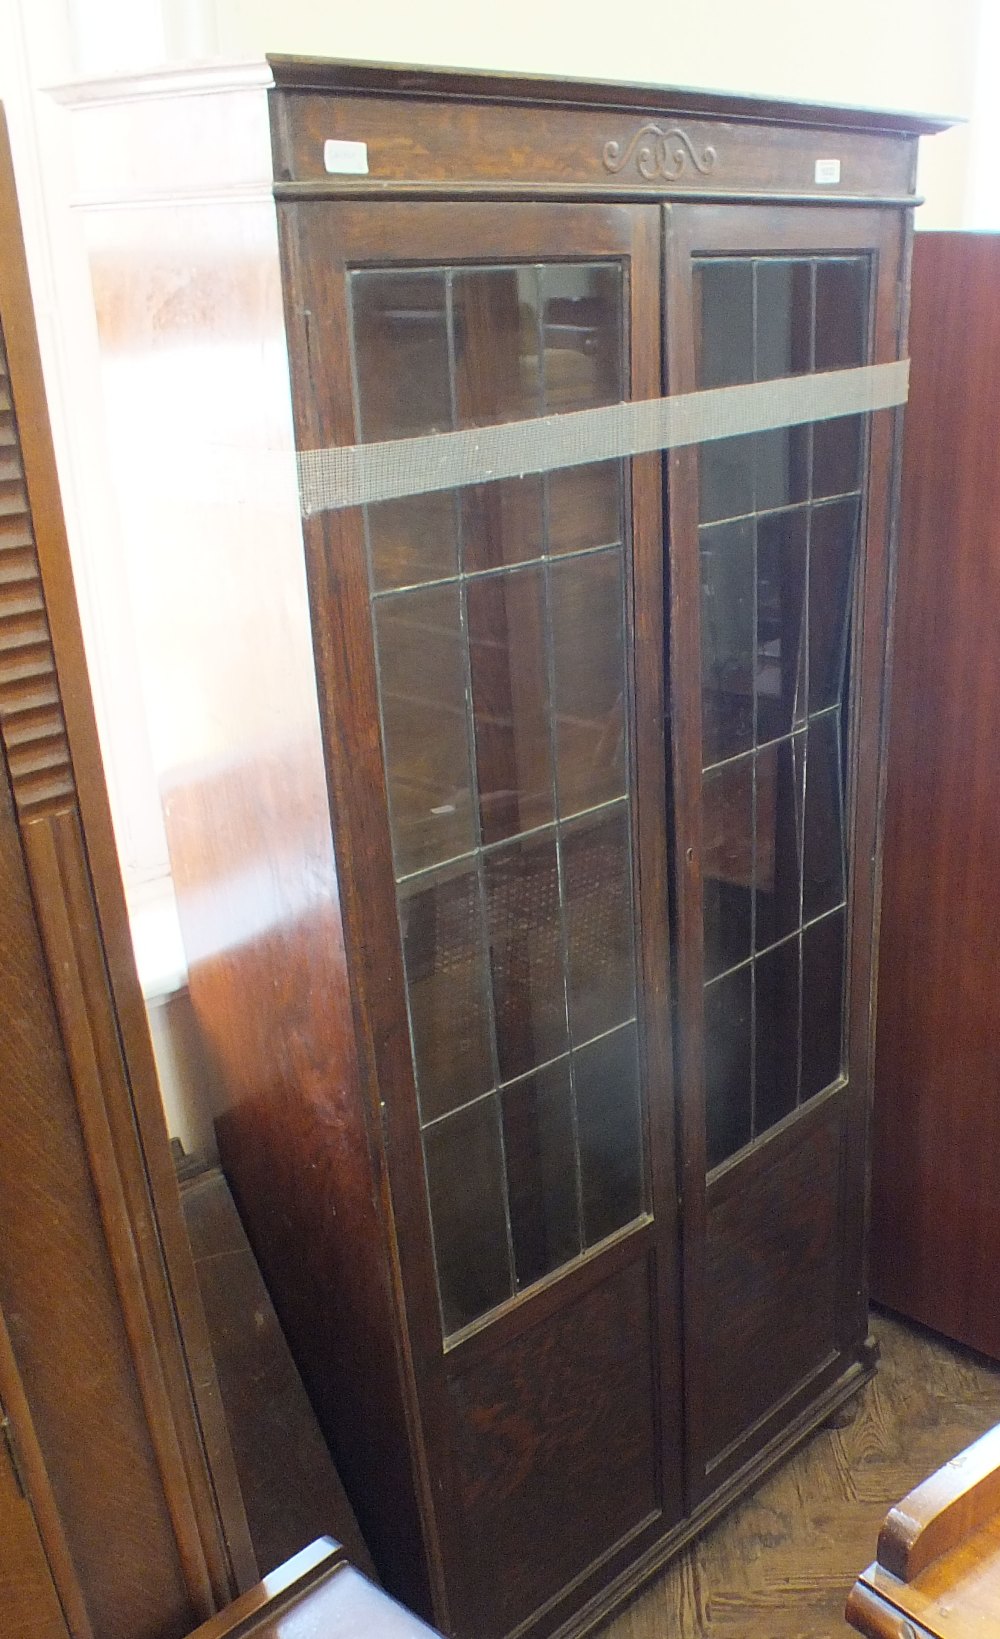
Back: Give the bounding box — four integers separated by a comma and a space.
877, 1424, 1000, 1582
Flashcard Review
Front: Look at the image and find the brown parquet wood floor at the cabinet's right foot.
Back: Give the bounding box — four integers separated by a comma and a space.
600, 1314, 1000, 1639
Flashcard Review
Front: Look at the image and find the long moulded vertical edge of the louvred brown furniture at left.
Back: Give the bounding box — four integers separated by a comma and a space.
0, 105, 256, 1614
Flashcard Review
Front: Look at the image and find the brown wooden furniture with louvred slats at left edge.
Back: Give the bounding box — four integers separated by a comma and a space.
0, 102, 254, 1639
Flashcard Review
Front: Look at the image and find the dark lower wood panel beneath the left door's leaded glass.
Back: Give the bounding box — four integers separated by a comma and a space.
448, 1257, 661, 1639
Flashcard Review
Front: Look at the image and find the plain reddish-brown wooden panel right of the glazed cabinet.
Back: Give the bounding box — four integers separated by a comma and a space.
872, 233, 1000, 1357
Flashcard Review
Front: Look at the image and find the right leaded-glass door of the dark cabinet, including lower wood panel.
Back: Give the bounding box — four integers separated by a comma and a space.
666, 207, 903, 1501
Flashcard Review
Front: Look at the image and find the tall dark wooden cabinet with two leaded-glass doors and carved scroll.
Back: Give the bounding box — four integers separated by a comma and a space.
54, 59, 933, 1639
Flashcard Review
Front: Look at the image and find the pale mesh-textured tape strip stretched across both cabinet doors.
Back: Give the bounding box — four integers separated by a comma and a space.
297, 359, 910, 518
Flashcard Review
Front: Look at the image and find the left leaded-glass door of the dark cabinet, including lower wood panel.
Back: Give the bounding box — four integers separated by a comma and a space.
284, 203, 680, 1639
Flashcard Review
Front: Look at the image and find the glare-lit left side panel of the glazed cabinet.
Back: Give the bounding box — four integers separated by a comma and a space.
78, 197, 426, 1606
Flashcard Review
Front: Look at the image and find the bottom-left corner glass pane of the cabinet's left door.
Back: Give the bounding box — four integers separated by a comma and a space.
423, 1098, 513, 1333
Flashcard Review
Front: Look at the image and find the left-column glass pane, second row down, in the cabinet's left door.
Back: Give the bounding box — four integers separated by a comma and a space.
374, 585, 475, 875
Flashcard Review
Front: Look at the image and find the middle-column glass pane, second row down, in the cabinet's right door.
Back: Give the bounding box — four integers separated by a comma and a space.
756, 508, 808, 744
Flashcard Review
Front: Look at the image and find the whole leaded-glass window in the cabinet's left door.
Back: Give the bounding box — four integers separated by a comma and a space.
351, 261, 643, 1333
